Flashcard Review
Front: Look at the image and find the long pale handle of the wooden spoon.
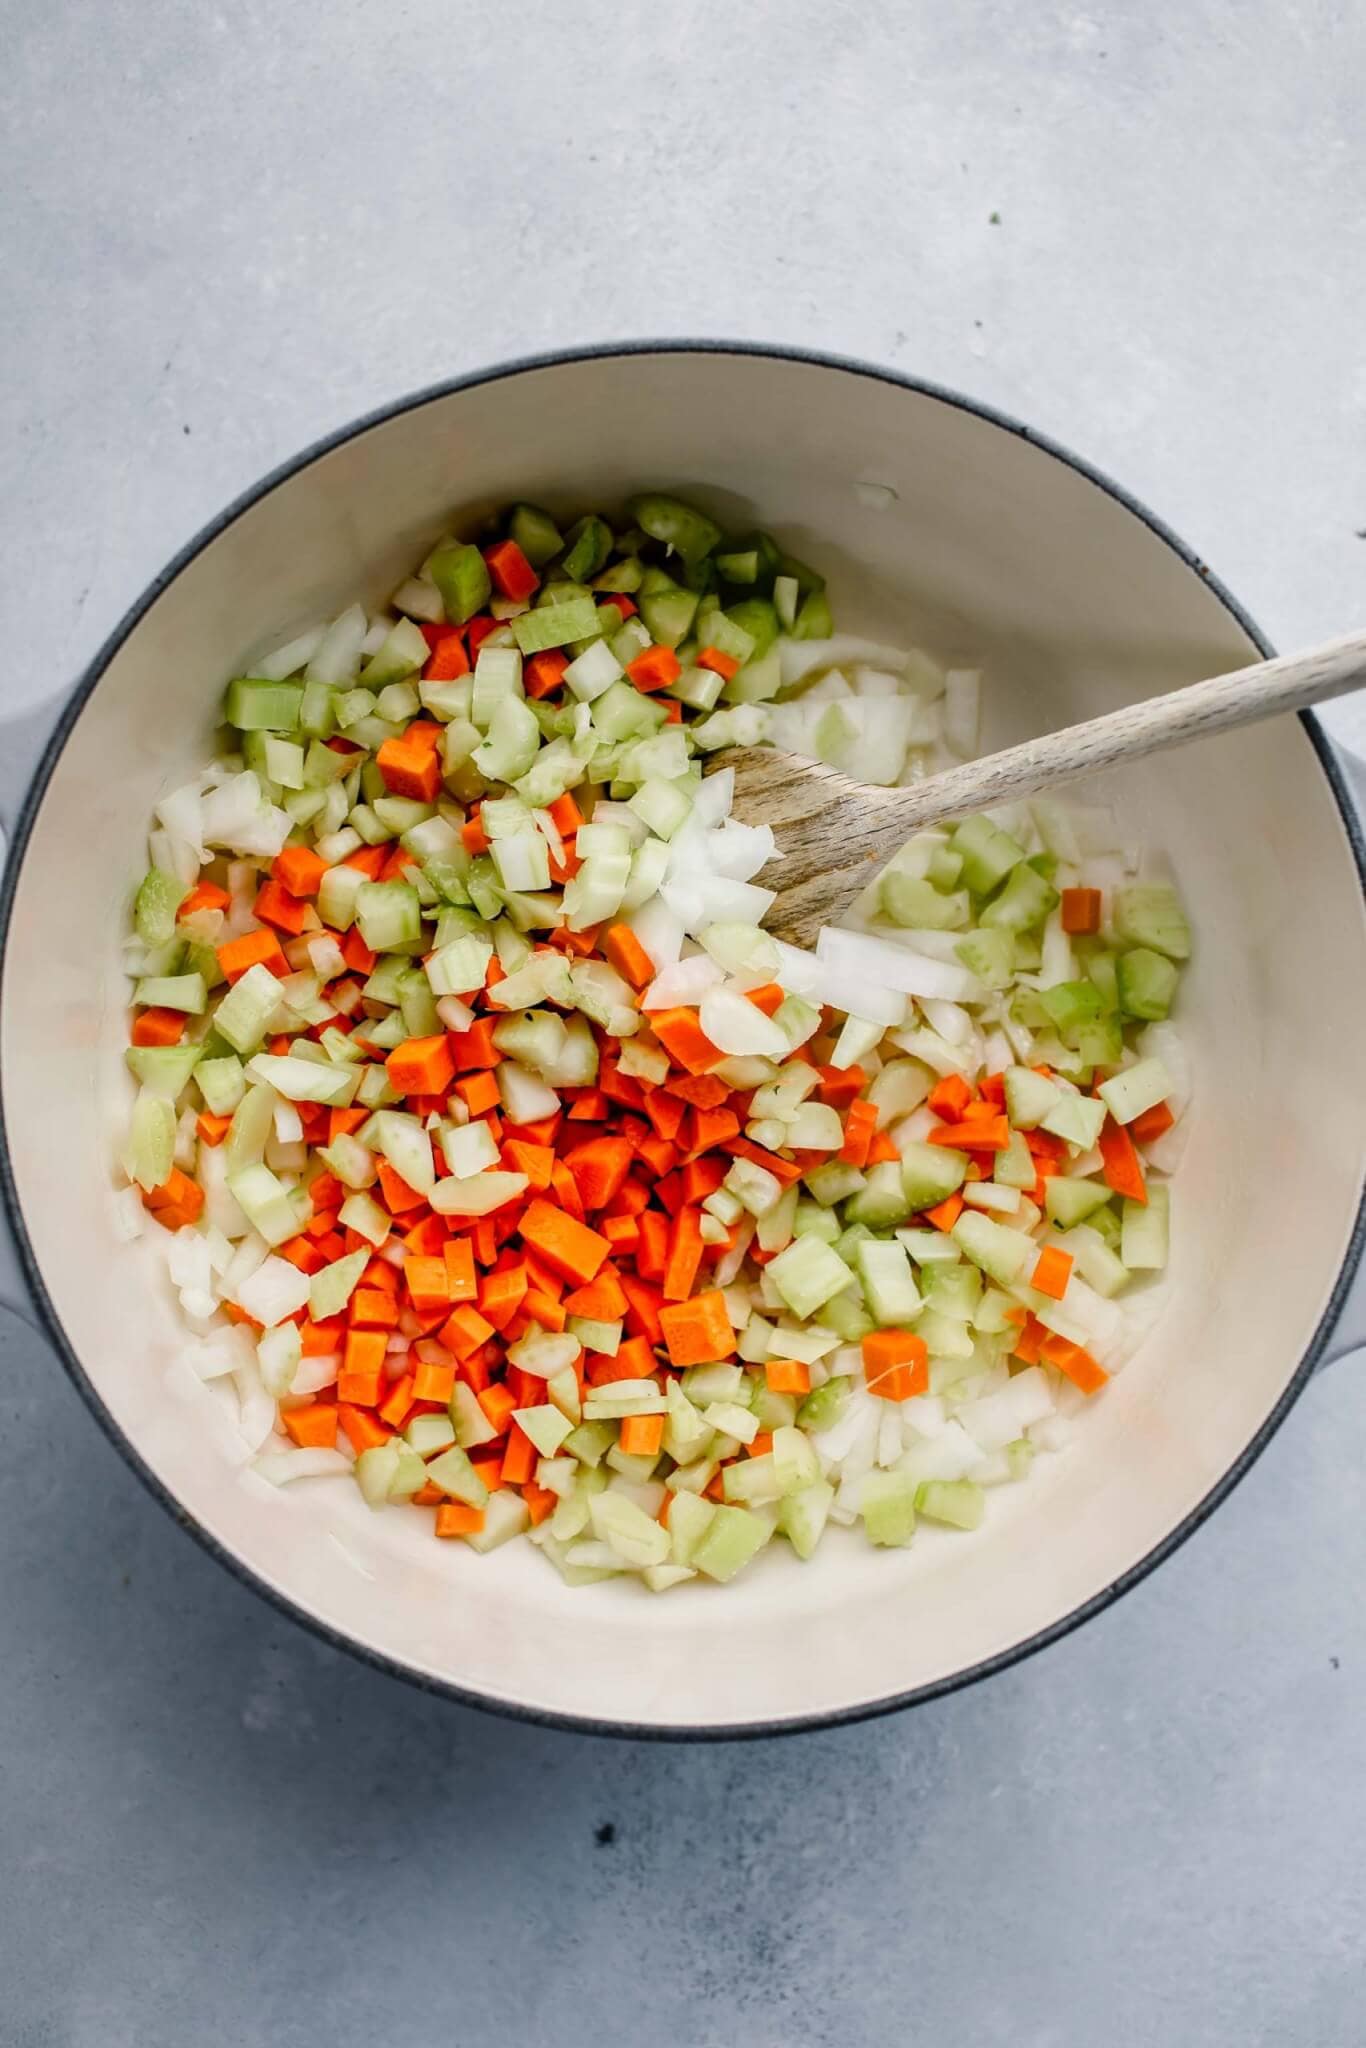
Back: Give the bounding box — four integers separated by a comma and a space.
868, 633, 1366, 848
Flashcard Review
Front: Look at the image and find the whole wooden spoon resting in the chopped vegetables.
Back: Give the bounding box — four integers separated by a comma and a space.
709, 633, 1366, 946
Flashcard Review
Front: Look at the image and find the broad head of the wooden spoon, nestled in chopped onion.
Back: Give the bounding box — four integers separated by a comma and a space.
707, 748, 909, 946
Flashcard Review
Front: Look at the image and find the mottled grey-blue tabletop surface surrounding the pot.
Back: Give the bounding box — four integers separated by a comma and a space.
0, 0, 1366, 2048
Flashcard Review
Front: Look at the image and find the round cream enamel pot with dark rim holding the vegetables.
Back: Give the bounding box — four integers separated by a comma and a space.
0, 344, 1366, 1735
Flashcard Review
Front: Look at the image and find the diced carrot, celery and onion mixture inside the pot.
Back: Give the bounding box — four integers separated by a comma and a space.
119, 494, 1190, 1591
